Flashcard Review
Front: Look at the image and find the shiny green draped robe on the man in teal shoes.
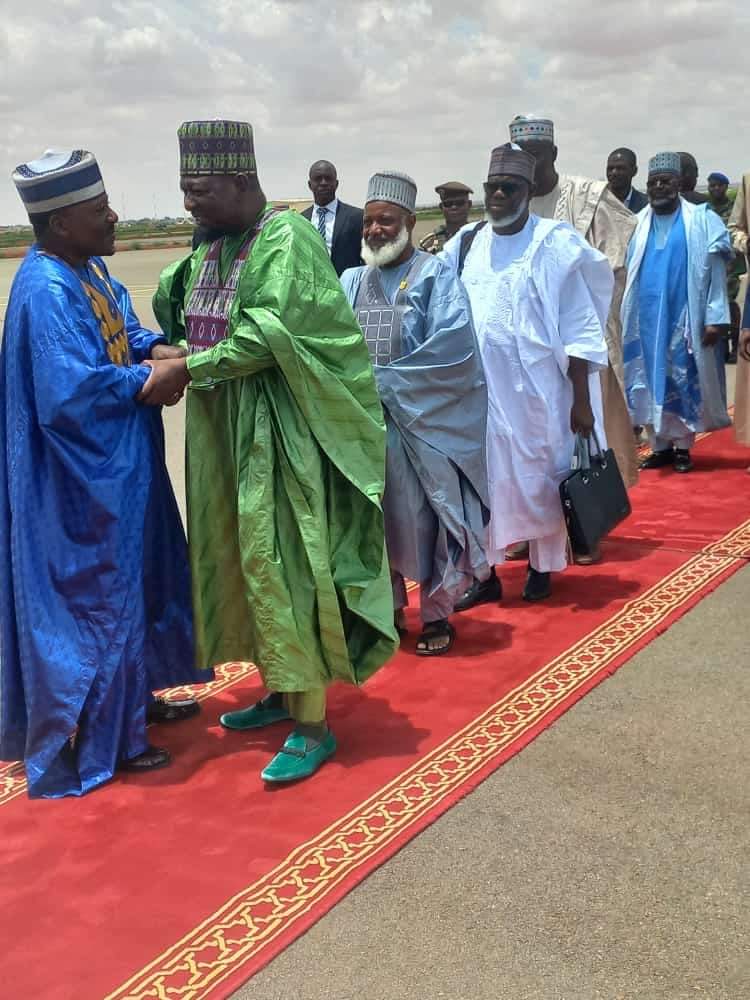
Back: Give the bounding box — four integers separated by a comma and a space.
154, 212, 396, 691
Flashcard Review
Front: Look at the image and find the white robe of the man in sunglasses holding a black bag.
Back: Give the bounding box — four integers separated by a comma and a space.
443, 216, 613, 560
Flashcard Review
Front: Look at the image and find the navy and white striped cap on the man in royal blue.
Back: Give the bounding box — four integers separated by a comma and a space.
13, 149, 104, 215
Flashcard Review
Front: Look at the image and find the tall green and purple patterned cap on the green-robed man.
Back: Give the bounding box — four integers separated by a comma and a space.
177, 120, 255, 177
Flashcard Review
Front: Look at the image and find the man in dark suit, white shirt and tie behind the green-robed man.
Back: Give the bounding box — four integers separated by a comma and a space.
302, 160, 362, 275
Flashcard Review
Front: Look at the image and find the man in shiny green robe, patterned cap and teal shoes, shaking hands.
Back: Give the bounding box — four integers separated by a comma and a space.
144, 121, 397, 782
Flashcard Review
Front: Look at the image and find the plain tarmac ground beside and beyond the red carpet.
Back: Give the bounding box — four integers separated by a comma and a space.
0, 248, 750, 1000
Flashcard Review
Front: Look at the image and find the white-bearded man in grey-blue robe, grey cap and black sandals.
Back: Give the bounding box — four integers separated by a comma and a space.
341, 171, 499, 656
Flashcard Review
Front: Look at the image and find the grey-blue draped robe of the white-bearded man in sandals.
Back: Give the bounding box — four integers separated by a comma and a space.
341, 251, 489, 597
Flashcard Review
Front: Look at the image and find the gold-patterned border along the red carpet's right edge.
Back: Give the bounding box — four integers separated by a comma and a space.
105, 521, 750, 1000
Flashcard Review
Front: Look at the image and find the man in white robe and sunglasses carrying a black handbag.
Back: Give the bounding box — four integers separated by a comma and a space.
443, 143, 614, 610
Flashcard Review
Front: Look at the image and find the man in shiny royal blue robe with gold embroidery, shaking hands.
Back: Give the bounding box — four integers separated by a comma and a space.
0, 150, 210, 797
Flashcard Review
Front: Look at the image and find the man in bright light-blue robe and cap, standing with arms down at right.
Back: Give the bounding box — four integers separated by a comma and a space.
622, 153, 731, 472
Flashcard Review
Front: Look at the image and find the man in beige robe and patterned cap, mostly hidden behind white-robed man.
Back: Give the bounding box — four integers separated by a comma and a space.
510, 115, 638, 500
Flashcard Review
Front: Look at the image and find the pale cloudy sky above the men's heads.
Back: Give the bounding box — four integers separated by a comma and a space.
0, 0, 750, 224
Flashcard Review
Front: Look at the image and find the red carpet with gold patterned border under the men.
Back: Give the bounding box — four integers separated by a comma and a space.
0, 431, 750, 1000
